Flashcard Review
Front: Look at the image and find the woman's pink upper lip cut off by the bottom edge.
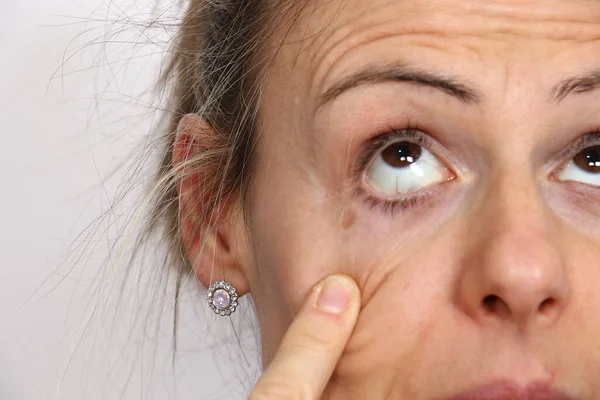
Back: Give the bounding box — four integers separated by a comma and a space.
444, 381, 574, 400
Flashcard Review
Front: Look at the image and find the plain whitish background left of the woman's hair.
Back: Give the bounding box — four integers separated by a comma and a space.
0, 0, 258, 400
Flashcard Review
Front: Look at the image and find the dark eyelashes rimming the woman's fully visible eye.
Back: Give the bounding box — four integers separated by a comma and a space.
353, 124, 446, 216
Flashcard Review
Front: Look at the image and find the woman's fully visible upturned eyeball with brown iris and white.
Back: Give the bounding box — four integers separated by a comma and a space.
366, 142, 448, 196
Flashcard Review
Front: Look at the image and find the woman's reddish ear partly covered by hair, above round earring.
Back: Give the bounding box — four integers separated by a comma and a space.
172, 114, 249, 295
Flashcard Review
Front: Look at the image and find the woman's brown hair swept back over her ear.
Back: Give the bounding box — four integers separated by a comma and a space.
131, 0, 306, 348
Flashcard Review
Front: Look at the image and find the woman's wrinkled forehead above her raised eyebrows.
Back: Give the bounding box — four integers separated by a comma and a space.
266, 0, 600, 111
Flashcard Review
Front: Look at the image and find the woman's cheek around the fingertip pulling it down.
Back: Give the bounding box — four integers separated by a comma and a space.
252, 175, 456, 377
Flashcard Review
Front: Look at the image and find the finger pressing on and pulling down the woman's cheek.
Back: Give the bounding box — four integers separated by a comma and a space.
250, 275, 360, 400
